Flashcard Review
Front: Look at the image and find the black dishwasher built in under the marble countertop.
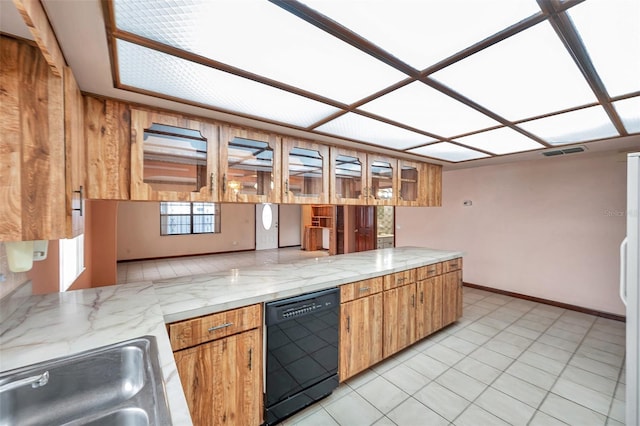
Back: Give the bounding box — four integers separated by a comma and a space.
265, 288, 340, 425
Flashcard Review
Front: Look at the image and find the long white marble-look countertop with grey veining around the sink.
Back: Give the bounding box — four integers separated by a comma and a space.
0, 247, 462, 425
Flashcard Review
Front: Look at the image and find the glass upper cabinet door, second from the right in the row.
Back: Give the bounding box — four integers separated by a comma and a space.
366, 154, 398, 206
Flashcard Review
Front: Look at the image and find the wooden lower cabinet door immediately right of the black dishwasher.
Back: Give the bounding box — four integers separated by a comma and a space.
338, 293, 382, 381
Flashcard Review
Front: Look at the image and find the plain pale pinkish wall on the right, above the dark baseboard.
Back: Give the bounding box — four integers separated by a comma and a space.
396, 153, 626, 315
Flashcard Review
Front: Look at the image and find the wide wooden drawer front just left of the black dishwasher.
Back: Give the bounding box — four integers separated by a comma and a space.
169, 304, 262, 351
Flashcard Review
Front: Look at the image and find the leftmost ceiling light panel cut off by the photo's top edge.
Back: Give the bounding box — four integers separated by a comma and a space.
114, 0, 406, 104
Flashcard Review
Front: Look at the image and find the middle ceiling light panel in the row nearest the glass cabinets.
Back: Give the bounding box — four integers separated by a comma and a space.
315, 112, 435, 149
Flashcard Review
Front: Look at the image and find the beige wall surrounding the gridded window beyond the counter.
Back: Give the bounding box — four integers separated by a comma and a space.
117, 201, 256, 260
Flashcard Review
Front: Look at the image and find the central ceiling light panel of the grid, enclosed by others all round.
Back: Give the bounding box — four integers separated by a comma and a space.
361, 82, 500, 137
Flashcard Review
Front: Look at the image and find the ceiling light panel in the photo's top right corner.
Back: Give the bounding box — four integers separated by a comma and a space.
568, 0, 640, 96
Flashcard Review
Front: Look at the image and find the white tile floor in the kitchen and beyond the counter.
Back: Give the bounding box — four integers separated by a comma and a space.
118, 248, 625, 426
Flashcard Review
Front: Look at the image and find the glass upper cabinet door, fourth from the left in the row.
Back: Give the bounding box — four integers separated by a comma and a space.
330, 147, 367, 204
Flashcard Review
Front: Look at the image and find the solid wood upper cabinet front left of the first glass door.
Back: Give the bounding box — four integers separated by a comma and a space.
84, 96, 131, 200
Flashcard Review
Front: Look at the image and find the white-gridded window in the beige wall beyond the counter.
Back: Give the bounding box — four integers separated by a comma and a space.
160, 202, 220, 235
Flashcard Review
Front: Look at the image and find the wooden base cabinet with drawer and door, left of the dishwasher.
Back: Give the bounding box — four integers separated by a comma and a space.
168, 304, 263, 426
